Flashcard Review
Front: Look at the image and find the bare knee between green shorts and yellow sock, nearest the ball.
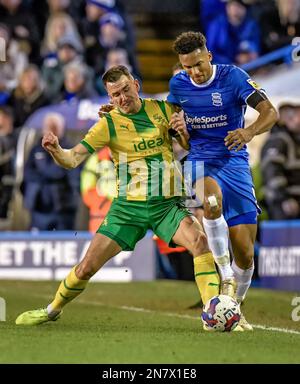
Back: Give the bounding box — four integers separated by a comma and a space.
172, 216, 209, 256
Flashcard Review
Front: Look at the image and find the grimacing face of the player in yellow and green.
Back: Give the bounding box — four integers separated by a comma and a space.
106, 75, 141, 114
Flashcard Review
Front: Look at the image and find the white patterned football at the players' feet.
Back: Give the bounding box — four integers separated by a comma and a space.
201, 295, 241, 332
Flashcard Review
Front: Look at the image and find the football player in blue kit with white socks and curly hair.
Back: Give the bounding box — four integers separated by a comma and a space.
168, 32, 277, 330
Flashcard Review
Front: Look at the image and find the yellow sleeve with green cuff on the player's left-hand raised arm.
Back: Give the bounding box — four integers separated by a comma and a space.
81, 117, 110, 153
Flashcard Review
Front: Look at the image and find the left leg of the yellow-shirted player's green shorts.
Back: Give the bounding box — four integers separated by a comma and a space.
97, 199, 148, 251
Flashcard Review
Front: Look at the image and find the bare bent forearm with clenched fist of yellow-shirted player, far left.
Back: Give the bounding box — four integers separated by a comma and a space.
42, 132, 89, 169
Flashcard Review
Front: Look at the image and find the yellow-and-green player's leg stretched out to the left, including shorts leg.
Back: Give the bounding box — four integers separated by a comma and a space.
16, 199, 148, 325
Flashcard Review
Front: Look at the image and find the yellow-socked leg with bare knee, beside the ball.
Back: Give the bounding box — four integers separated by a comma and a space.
172, 216, 220, 305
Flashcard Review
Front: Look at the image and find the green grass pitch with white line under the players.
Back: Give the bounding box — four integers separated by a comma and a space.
0, 280, 300, 364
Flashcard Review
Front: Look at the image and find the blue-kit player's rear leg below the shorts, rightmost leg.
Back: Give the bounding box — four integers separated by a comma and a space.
229, 220, 257, 330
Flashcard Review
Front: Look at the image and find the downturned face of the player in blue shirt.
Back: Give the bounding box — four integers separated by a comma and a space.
179, 48, 213, 84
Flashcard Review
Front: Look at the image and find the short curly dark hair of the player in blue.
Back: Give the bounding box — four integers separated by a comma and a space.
173, 31, 206, 55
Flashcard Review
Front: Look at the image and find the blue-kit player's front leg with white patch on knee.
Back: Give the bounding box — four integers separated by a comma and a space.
196, 176, 235, 296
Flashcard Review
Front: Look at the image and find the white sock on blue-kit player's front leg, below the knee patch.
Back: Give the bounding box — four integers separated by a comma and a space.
202, 215, 233, 280
